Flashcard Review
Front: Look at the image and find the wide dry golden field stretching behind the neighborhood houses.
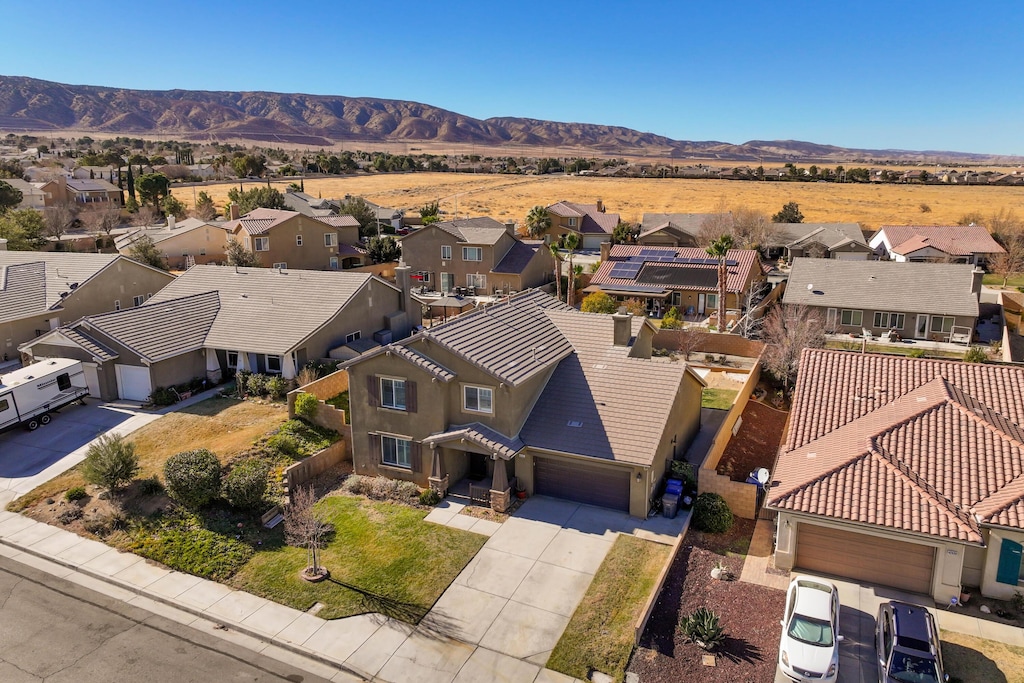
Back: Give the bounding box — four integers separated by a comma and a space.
174, 173, 1024, 229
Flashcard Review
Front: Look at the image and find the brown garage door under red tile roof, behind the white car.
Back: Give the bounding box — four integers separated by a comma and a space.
797, 524, 935, 595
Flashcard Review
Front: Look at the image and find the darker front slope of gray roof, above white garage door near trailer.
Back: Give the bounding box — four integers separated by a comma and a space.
78, 292, 220, 362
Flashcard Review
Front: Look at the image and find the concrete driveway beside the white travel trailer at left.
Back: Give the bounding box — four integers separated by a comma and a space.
0, 398, 161, 507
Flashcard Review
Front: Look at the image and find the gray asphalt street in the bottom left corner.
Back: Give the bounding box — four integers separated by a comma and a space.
0, 557, 325, 683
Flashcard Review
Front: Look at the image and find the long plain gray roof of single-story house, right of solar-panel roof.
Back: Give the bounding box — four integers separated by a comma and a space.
782, 258, 978, 317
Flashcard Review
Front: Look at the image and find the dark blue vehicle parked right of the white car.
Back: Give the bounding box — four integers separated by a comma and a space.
874, 600, 949, 683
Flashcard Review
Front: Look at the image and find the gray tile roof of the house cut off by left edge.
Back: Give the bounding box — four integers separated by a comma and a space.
0, 251, 127, 323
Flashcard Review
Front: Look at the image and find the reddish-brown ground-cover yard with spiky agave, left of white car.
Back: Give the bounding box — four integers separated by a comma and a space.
628, 520, 785, 683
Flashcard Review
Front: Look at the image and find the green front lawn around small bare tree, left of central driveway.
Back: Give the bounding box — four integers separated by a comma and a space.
229, 496, 486, 624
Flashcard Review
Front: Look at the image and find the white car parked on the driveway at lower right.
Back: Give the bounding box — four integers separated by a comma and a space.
778, 577, 843, 683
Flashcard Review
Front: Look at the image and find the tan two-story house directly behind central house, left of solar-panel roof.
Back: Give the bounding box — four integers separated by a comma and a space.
401, 217, 553, 294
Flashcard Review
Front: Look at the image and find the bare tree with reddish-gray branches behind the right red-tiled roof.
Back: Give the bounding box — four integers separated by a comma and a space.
763, 304, 825, 390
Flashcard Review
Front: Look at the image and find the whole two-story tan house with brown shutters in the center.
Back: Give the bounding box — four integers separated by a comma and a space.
342, 290, 705, 517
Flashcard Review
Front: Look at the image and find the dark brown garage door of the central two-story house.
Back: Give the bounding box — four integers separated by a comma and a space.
534, 458, 630, 512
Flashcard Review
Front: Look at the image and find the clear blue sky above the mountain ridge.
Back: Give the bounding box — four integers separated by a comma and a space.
0, 0, 1024, 155
